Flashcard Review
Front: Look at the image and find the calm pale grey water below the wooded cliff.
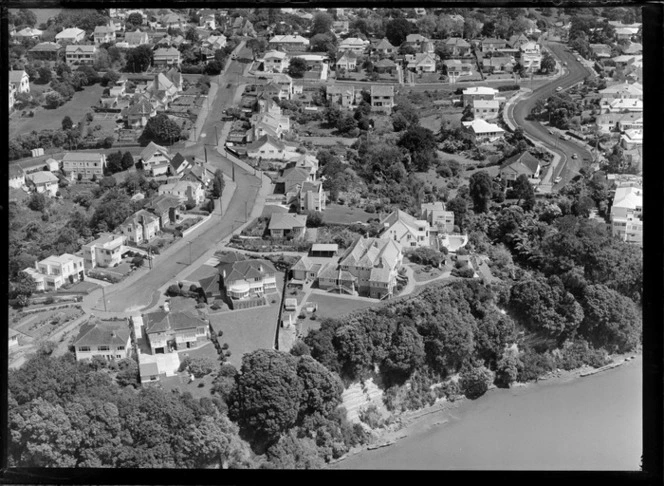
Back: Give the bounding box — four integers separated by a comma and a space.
334, 356, 642, 470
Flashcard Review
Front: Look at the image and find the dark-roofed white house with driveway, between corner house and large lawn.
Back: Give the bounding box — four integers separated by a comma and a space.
142, 307, 210, 354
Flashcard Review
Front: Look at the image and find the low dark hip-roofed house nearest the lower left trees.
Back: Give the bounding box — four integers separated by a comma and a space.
74, 317, 131, 361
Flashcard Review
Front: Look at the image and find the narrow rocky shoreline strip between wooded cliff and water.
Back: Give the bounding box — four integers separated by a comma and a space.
330, 349, 642, 469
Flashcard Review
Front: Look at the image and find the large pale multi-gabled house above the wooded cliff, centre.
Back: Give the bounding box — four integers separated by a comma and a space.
318, 238, 403, 299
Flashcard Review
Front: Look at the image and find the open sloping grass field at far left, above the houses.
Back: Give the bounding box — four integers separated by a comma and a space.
9, 84, 104, 137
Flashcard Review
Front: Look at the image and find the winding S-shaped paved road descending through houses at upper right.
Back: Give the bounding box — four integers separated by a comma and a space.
508, 42, 592, 190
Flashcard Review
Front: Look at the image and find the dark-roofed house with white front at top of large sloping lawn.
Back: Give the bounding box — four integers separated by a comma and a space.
219, 259, 278, 309
